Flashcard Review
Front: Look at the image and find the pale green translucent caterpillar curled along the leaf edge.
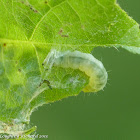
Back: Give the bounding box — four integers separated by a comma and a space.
43, 49, 108, 92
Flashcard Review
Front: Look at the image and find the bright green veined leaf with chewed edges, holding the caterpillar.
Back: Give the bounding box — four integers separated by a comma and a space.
0, 0, 140, 134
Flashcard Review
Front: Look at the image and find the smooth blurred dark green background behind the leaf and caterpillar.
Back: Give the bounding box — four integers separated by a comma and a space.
31, 0, 140, 140
